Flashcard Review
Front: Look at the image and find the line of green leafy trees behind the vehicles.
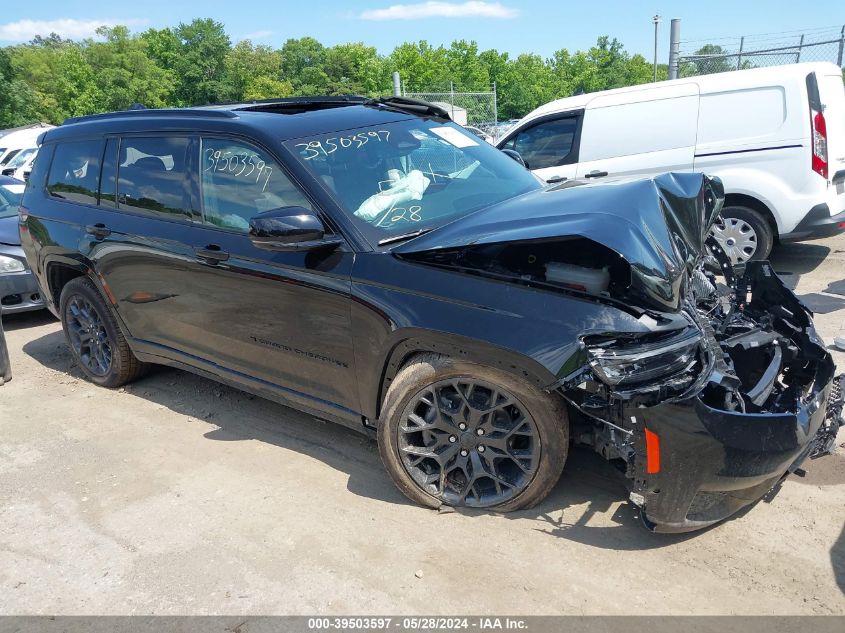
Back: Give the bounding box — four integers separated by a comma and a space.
0, 18, 667, 128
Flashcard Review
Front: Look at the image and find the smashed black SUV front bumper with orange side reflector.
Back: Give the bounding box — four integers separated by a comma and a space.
561, 262, 845, 532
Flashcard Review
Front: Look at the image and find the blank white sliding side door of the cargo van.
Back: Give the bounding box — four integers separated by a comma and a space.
577, 83, 698, 179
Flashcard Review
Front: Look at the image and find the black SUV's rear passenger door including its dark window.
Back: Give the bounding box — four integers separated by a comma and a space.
81, 135, 199, 356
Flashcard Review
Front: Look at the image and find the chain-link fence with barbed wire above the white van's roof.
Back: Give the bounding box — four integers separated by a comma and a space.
679, 26, 845, 77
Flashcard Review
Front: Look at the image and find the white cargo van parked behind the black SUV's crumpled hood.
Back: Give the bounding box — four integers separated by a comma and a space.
497, 63, 845, 263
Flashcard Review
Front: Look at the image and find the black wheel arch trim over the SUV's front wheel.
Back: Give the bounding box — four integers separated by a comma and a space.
364, 329, 557, 420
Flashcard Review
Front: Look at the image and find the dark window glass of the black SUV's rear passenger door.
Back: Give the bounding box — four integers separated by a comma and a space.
117, 137, 192, 218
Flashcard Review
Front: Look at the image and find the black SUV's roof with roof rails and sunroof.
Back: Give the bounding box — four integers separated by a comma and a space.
42, 95, 449, 142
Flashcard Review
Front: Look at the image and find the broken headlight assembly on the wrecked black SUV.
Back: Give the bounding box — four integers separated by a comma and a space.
584, 328, 702, 387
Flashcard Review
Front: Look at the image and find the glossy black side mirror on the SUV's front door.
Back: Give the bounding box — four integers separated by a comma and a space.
249, 207, 341, 251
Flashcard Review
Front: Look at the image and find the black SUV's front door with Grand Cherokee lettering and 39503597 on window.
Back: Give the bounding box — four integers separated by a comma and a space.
183, 137, 360, 413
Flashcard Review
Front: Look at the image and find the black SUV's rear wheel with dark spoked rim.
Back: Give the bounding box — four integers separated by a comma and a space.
59, 277, 146, 387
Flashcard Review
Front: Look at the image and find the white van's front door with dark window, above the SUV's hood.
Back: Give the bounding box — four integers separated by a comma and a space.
501, 110, 583, 181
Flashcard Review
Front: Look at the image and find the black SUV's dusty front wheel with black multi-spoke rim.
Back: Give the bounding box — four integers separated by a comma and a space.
378, 354, 569, 512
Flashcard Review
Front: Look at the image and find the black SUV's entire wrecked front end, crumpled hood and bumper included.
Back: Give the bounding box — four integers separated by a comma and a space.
394, 174, 843, 532
